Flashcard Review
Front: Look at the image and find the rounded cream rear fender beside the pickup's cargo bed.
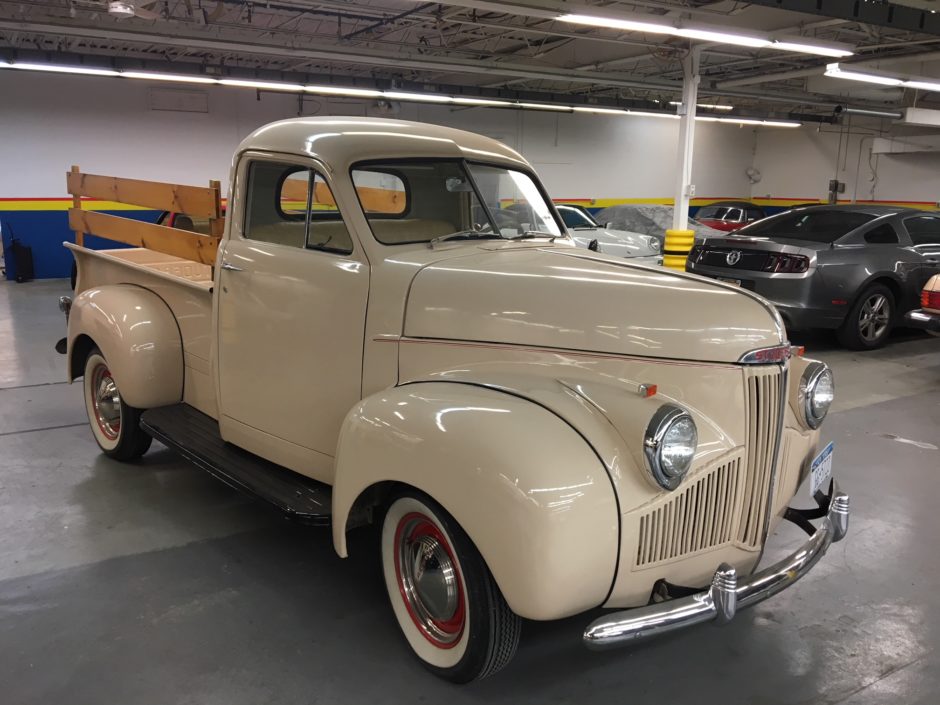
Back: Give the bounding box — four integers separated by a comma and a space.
68, 284, 183, 409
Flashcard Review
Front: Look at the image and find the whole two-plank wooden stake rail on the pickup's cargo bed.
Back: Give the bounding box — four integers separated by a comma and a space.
67, 166, 225, 266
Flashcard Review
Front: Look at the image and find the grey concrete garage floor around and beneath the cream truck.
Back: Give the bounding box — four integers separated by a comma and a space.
0, 281, 940, 705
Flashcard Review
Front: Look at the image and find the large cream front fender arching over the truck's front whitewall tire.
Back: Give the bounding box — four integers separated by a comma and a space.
333, 382, 620, 619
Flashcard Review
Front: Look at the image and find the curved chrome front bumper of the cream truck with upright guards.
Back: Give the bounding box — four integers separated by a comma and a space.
584, 484, 849, 651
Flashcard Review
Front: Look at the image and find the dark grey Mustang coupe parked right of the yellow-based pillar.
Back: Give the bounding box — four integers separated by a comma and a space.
686, 205, 940, 350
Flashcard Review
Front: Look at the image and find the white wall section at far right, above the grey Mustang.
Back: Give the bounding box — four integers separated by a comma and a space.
751, 121, 940, 203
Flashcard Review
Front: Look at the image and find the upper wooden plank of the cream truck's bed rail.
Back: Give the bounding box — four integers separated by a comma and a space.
66, 167, 221, 218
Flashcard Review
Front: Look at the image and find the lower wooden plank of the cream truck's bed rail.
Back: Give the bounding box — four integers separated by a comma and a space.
69, 208, 219, 266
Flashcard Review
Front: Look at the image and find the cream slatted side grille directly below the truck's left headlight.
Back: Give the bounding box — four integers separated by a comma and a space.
636, 458, 742, 566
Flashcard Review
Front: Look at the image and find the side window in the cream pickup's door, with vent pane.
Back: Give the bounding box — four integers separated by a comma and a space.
244, 161, 352, 254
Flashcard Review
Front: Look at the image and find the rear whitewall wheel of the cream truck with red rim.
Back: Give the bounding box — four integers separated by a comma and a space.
84, 348, 153, 461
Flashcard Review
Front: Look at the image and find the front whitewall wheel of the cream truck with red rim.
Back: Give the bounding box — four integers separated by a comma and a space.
381, 492, 521, 683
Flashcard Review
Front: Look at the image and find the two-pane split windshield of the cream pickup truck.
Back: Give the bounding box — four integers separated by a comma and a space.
351, 159, 561, 245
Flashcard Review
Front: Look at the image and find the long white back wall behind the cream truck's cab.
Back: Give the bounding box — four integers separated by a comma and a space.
0, 70, 755, 199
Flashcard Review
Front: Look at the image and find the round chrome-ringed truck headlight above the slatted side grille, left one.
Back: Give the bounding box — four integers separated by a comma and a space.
643, 404, 698, 490
